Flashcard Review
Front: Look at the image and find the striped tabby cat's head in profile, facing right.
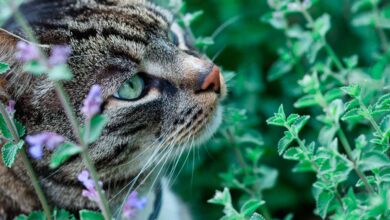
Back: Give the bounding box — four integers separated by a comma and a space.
0, 0, 226, 205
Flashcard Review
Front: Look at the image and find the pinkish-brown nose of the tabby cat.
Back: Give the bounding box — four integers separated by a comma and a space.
197, 65, 221, 93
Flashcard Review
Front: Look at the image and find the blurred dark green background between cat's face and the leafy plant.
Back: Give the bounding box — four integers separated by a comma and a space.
153, 0, 379, 219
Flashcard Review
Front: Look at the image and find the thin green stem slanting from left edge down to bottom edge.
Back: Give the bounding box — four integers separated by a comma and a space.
0, 103, 51, 220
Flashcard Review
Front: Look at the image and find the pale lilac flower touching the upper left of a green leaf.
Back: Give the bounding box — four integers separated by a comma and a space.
26, 132, 65, 160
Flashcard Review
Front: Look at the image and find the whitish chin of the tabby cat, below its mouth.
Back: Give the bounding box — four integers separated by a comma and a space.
194, 106, 223, 146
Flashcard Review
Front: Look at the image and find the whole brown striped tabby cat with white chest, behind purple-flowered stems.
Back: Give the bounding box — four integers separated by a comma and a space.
0, 0, 226, 220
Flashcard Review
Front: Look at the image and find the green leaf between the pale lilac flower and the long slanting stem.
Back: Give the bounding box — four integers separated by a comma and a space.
50, 142, 81, 169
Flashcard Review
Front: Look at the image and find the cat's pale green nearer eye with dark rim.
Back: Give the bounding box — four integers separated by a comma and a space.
114, 75, 145, 101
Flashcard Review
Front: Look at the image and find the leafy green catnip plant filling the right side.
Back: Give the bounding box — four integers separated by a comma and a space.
263, 0, 390, 219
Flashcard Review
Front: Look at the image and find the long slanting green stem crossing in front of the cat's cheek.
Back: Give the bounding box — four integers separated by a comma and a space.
54, 82, 112, 220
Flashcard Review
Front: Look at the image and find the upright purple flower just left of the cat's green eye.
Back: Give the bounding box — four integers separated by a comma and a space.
81, 85, 103, 118
